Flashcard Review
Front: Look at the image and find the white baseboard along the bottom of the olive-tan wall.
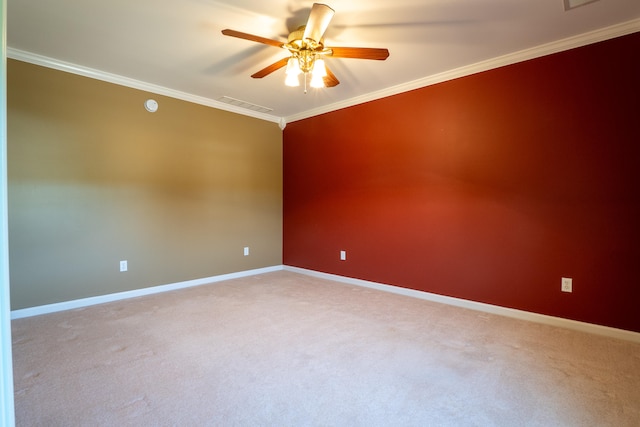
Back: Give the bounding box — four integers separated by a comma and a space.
11, 265, 283, 320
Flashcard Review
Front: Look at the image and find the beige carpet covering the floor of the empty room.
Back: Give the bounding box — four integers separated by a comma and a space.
12, 271, 640, 427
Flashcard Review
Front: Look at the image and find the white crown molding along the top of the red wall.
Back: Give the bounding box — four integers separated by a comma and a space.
286, 19, 640, 123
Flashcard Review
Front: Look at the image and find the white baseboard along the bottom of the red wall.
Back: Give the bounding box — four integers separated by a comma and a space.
283, 266, 640, 343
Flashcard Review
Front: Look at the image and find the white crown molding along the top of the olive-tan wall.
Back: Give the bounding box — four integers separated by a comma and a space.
7, 47, 280, 123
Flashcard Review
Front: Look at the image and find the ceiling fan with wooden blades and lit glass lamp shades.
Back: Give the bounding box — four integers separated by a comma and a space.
222, 3, 389, 93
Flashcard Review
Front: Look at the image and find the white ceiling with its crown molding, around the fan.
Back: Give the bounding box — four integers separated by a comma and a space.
7, 0, 640, 122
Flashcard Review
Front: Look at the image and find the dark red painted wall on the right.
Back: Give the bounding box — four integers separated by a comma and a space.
284, 33, 640, 332
